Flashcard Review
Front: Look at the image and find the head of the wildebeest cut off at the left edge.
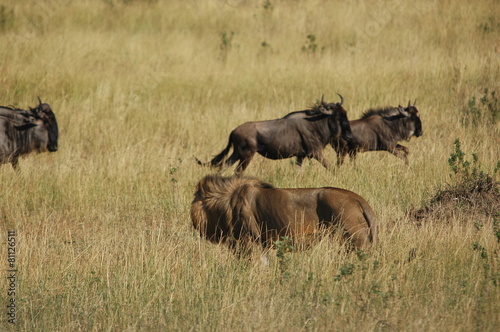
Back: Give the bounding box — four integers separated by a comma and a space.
30, 98, 59, 152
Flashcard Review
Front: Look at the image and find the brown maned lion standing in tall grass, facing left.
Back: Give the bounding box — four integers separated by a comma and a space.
190, 175, 377, 249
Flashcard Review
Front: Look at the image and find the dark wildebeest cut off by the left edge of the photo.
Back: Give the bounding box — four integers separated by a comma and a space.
0, 98, 59, 168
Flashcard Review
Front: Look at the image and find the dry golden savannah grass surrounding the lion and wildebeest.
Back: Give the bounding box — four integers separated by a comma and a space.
0, 0, 500, 331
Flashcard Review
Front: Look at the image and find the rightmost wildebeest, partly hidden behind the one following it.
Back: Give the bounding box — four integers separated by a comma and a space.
334, 101, 422, 165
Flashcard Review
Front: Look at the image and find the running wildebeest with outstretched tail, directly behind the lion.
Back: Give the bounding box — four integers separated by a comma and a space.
197, 95, 351, 174
